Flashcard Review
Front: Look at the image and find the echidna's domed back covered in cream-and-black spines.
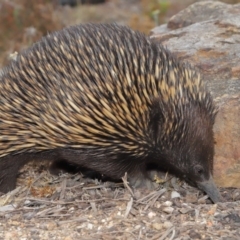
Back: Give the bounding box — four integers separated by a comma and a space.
0, 24, 214, 156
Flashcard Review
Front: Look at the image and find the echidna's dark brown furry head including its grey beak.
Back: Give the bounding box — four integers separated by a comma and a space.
150, 98, 221, 202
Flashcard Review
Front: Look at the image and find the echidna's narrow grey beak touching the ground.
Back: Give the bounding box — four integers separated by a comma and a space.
197, 176, 222, 203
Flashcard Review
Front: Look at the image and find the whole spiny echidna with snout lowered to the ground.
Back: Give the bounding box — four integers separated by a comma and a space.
0, 24, 220, 202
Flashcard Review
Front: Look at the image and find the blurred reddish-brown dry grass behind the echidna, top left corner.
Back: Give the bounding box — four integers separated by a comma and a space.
0, 0, 63, 67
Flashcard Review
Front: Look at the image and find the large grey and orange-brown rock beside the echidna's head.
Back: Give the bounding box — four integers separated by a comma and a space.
151, 1, 240, 188
